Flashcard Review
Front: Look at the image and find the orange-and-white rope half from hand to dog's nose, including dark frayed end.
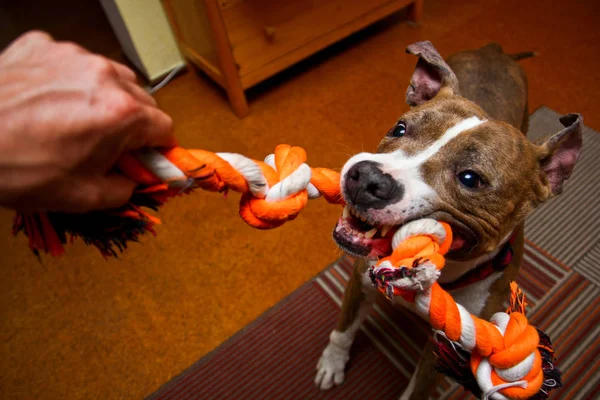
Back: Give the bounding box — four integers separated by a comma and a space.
13, 144, 344, 257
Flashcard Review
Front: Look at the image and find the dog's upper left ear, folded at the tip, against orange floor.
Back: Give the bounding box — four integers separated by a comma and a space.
406, 41, 460, 107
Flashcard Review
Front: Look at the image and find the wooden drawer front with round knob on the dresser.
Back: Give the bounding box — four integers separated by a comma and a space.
221, 0, 394, 77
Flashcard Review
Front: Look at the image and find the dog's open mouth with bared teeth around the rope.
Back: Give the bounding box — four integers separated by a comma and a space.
333, 206, 472, 258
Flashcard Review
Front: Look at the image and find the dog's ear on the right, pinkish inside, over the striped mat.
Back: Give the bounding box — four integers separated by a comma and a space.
538, 114, 583, 197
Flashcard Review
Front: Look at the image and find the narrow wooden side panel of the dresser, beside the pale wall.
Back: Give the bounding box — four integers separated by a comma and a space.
165, 0, 220, 69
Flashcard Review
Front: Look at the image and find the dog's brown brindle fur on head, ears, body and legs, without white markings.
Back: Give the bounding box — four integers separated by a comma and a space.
316, 42, 581, 400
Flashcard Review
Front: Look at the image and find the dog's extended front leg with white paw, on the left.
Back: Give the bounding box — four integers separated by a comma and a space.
315, 259, 375, 390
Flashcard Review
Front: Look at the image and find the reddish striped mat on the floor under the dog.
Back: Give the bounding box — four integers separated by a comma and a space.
150, 243, 600, 400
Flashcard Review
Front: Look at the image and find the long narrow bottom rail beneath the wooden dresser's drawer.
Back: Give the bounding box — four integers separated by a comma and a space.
241, 0, 412, 88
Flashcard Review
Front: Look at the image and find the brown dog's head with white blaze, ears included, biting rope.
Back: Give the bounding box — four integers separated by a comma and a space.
333, 42, 582, 260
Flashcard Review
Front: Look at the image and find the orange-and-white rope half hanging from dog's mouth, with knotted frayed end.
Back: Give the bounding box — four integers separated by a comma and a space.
369, 219, 561, 400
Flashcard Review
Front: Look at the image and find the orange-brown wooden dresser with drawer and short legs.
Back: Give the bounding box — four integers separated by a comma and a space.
163, 0, 424, 117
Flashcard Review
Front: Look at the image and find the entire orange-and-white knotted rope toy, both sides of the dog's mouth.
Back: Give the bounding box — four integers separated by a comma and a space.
13, 145, 561, 400
